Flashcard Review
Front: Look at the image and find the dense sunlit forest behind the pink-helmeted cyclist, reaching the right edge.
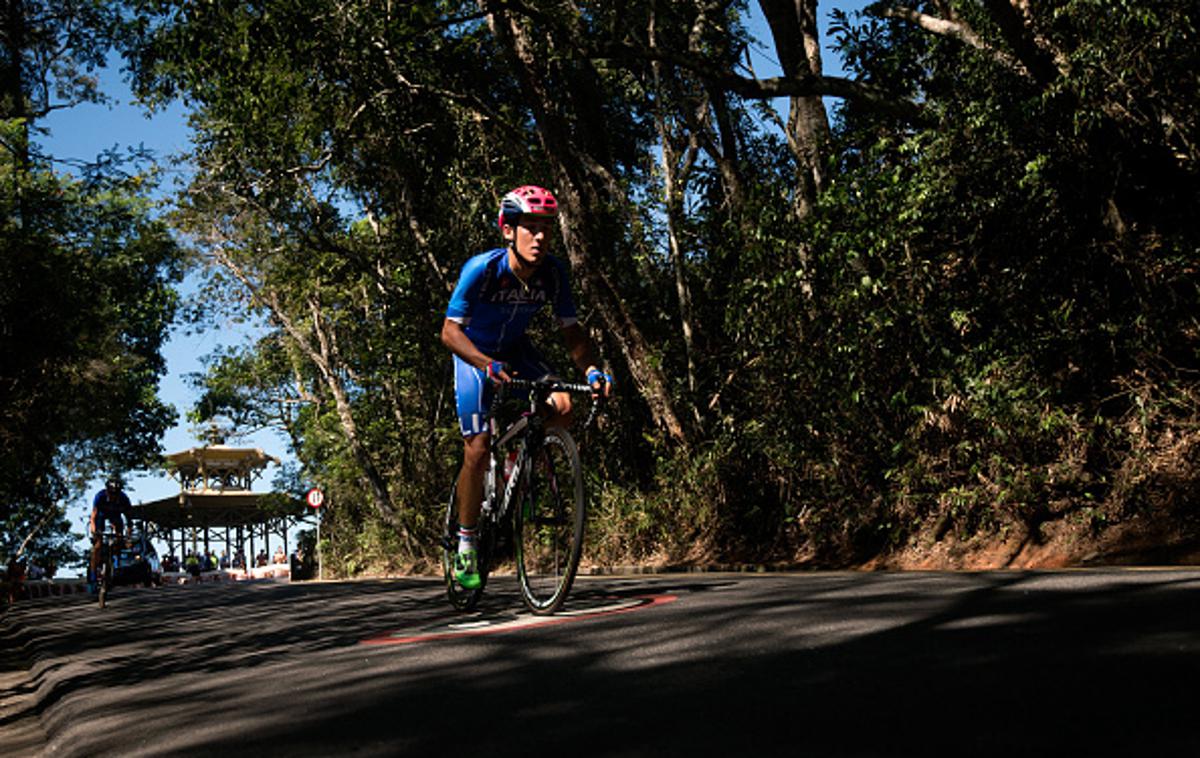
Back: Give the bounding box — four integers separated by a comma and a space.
5, 0, 1200, 572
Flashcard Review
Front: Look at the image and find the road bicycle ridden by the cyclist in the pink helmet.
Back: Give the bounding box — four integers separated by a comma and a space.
442, 379, 602, 614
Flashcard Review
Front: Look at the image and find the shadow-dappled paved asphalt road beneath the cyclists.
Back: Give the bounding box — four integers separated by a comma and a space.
0, 570, 1200, 758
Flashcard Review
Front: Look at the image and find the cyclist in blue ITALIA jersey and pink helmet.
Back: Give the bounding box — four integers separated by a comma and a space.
442, 185, 612, 589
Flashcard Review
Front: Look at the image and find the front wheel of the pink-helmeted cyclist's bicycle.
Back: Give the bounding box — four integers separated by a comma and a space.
514, 427, 587, 614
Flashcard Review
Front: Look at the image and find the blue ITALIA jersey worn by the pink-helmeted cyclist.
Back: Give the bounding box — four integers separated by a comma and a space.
446, 247, 578, 359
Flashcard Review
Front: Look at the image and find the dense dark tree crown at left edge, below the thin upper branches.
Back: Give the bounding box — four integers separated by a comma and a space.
0, 148, 179, 563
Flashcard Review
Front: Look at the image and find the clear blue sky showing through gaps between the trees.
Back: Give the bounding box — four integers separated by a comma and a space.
40, 0, 866, 563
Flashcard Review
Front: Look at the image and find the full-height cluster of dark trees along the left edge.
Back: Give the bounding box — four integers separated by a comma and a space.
0, 0, 181, 567
